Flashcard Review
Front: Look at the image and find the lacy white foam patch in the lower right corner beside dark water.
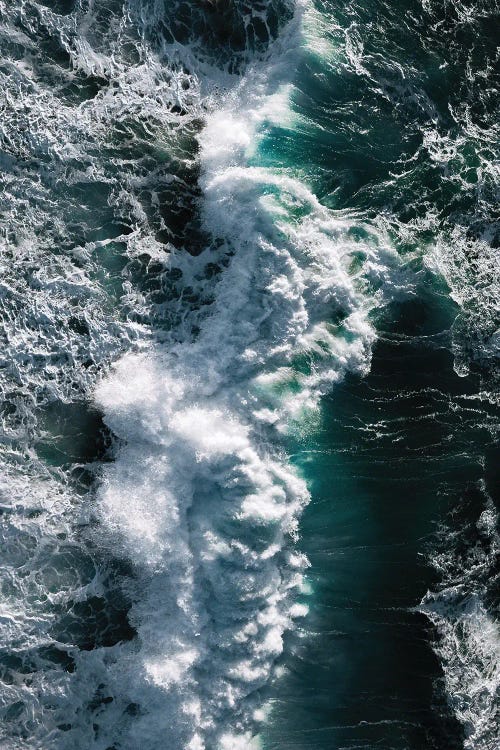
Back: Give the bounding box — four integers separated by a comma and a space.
420, 499, 500, 750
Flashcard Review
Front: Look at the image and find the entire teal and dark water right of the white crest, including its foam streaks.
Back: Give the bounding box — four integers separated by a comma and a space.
258, 2, 500, 750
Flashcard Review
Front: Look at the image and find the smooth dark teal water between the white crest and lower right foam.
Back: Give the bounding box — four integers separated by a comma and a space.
264, 279, 498, 750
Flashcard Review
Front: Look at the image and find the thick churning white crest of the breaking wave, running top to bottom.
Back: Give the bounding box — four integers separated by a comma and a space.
93, 3, 406, 750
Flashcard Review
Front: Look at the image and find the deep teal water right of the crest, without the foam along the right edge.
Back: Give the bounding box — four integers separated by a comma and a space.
264, 2, 500, 750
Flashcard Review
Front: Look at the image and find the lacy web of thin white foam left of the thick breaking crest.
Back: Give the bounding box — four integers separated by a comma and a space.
0, 2, 225, 750
